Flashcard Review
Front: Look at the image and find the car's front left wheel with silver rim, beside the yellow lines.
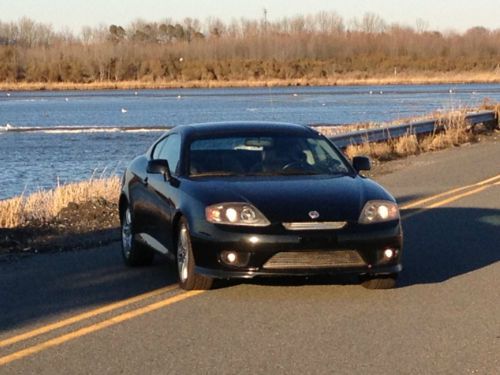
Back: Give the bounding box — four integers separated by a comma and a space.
177, 218, 213, 290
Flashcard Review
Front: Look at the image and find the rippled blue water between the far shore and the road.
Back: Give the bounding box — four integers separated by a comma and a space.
0, 84, 500, 199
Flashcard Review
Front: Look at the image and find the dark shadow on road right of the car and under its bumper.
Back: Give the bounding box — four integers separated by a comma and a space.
237, 207, 500, 288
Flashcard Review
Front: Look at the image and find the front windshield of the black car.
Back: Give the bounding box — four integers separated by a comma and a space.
189, 134, 351, 177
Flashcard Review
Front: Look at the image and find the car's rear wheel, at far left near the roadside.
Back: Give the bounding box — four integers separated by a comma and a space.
121, 207, 154, 267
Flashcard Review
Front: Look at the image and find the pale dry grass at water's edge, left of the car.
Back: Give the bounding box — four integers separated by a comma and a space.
0, 176, 120, 228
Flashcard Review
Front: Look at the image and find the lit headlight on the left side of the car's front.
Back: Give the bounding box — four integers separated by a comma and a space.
205, 203, 271, 227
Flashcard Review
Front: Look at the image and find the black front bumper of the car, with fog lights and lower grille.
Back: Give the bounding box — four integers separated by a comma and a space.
191, 221, 403, 278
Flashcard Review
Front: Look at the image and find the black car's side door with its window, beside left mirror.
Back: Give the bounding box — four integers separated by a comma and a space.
147, 133, 181, 251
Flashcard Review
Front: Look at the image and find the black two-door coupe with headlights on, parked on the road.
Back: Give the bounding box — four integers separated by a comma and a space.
119, 122, 402, 289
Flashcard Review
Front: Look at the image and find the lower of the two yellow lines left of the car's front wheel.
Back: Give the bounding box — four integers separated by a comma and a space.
0, 290, 203, 366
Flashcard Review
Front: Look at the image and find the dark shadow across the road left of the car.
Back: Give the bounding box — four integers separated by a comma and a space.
0, 242, 177, 334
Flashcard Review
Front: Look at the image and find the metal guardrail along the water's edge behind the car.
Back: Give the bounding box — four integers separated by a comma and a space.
330, 111, 498, 148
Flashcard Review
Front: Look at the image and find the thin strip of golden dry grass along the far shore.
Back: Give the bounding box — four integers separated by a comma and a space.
0, 71, 500, 91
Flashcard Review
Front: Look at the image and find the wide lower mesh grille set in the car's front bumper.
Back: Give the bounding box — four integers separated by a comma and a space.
264, 250, 366, 269
